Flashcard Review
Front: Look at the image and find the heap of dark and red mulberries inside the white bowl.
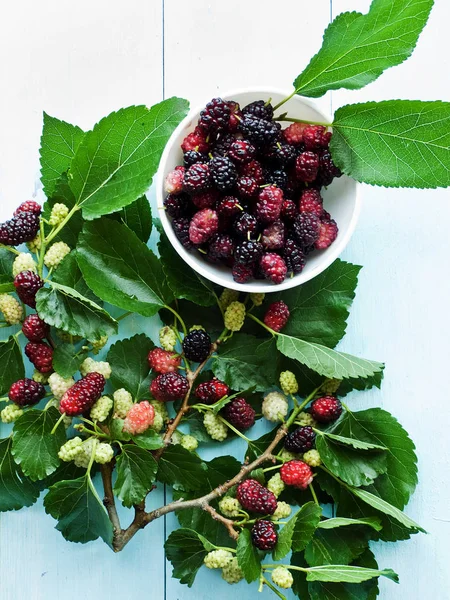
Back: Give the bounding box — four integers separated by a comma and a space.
164, 98, 341, 284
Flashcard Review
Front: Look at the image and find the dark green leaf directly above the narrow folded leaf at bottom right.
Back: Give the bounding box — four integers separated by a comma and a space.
305, 526, 370, 567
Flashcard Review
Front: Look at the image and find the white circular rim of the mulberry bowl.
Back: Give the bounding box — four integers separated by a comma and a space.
155, 86, 362, 294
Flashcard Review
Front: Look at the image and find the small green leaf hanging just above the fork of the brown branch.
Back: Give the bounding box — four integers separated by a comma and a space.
114, 444, 158, 508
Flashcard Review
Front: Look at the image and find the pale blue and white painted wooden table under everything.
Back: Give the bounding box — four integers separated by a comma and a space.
0, 0, 450, 600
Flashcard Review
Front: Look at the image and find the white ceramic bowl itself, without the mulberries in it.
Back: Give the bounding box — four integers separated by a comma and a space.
156, 89, 360, 293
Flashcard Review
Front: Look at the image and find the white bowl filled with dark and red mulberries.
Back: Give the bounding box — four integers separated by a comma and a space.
157, 90, 360, 292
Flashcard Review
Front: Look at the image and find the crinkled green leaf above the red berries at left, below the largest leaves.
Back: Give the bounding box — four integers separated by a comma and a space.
36, 281, 118, 340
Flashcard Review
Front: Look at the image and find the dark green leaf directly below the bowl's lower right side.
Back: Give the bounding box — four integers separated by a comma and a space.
272, 259, 361, 347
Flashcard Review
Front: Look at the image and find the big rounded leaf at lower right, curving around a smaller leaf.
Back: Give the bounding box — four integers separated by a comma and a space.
330, 408, 417, 509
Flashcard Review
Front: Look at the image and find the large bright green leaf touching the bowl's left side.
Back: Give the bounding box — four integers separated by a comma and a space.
69, 98, 189, 220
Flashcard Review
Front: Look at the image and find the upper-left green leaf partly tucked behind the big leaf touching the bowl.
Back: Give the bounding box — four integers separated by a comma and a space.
40, 112, 84, 198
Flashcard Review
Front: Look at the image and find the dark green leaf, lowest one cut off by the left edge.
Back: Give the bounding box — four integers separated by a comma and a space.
0, 437, 40, 512
